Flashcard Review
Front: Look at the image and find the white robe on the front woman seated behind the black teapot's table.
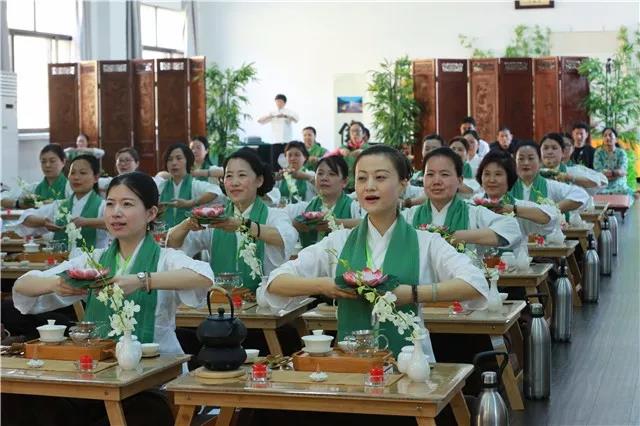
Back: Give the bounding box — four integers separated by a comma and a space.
258, 221, 489, 361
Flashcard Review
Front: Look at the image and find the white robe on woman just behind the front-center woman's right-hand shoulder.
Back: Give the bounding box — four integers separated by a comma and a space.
402, 200, 522, 248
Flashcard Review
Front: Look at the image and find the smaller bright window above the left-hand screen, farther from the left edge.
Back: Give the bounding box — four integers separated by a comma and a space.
140, 4, 186, 59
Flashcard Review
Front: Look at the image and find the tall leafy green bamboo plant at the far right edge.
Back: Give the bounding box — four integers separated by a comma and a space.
579, 27, 640, 190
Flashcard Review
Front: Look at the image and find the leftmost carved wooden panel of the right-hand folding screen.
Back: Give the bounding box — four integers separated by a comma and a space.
413, 59, 437, 167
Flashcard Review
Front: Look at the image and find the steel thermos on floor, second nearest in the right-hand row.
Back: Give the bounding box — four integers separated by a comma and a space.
523, 303, 551, 399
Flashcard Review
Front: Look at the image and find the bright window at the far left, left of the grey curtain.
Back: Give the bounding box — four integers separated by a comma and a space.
7, 0, 76, 131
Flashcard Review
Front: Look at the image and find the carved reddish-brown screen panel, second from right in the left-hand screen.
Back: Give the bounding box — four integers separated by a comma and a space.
156, 59, 189, 161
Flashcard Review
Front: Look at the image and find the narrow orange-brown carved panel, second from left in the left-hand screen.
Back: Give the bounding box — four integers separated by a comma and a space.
79, 61, 100, 147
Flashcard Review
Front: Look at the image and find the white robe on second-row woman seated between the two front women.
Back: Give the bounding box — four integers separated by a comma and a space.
180, 204, 298, 276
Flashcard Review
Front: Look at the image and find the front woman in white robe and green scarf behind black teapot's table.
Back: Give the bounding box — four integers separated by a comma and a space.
258, 146, 488, 359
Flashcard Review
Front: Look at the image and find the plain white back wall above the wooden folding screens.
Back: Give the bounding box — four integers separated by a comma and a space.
199, 0, 640, 146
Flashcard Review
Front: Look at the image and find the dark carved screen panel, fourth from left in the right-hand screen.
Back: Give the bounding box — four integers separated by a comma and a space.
498, 58, 533, 140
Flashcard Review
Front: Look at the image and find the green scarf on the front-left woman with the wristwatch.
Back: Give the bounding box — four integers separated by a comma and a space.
84, 233, 160, 343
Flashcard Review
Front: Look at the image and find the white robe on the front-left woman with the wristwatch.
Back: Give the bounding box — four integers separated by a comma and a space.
13, 243, 213, 354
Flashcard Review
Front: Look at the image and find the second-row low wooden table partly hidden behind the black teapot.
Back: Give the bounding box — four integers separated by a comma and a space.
176, 298, 315, 355
